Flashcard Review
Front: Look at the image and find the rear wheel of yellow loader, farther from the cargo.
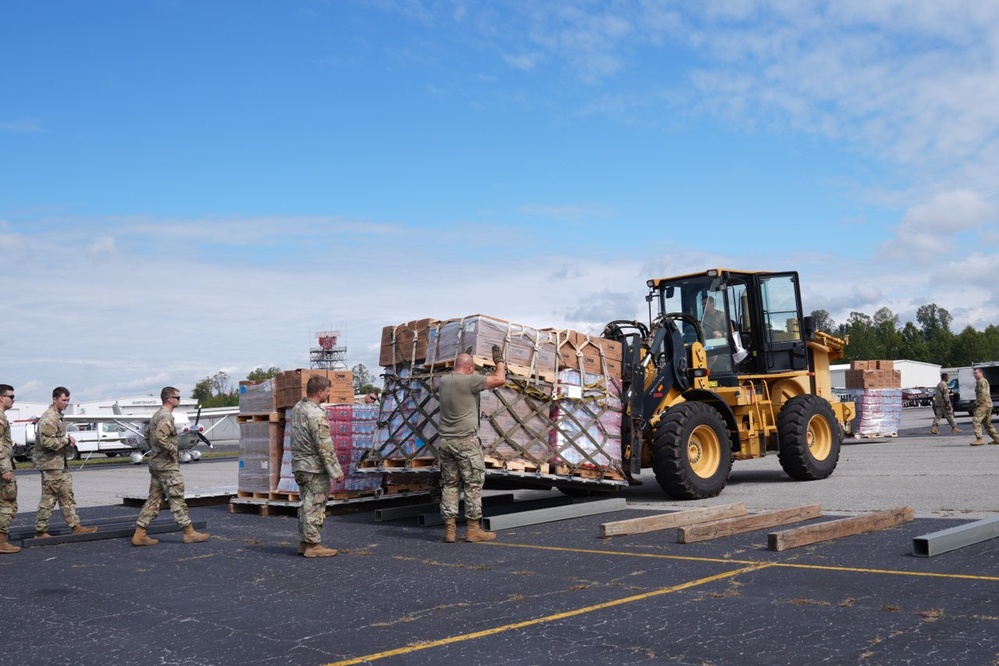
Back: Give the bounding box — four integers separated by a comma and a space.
777, 395, 843, 481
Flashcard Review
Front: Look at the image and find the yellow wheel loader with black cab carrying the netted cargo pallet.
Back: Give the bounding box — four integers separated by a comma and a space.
603, 269, 854, 499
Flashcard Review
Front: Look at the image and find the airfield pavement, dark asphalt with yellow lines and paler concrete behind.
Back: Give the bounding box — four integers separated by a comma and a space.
0, 409, 999, 666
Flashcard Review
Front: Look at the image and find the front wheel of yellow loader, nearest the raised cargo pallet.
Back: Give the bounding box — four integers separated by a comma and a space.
652, 402, 732, 499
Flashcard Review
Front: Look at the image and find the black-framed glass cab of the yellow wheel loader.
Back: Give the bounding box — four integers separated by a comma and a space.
649, 270, 810, 376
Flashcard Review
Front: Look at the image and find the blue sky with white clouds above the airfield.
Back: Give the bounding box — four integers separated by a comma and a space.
0, 0, 999, 401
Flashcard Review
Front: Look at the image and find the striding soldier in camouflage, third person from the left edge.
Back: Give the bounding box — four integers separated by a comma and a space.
132, 386, 210, 546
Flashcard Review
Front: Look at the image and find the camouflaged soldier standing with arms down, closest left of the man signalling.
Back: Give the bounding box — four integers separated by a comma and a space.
290, 375, 343, 557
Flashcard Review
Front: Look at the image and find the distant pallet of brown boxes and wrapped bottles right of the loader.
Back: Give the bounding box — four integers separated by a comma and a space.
846, 361, 902, 437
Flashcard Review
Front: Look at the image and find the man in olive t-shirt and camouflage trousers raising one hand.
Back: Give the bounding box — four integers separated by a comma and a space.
437, 345, 506, 543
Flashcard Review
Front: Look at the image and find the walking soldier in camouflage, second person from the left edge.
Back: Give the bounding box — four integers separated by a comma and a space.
32, 386, 97, 539
